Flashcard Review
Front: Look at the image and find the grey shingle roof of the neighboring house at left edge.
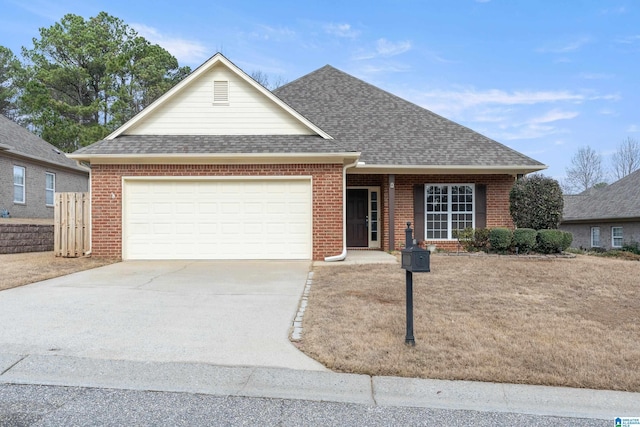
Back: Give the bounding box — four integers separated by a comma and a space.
0, 114, 88, 173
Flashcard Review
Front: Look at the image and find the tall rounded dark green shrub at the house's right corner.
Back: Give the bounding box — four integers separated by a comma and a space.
509, 174, 564, 230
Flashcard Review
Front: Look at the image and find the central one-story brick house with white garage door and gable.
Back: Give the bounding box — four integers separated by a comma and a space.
70, 54, 545, 260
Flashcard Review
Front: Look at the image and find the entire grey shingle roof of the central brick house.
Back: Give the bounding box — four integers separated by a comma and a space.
74, 65, 544, 170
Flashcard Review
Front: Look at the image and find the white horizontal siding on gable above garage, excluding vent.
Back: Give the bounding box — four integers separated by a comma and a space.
123, 64, 315, 135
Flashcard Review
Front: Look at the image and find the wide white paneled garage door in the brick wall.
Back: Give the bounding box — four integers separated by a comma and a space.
122, 178, 311, 259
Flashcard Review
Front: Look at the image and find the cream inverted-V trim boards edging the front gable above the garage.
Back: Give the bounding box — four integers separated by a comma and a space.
105, 53, 333, 139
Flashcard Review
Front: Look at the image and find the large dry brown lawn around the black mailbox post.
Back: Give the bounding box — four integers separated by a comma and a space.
300, 256, 640, 392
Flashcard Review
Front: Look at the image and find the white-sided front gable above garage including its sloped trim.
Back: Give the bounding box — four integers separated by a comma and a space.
106, 53, 331, 140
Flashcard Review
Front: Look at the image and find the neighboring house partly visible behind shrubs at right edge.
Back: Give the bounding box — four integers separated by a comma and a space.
560, 170, 640, 249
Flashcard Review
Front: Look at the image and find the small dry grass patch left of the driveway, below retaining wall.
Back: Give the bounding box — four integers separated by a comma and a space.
0, 252, 115, 291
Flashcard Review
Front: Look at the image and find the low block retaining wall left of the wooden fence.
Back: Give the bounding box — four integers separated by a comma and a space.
0, 224, 53, 254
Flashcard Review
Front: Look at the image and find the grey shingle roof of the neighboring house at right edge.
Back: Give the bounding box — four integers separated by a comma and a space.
562, 170, 640, 222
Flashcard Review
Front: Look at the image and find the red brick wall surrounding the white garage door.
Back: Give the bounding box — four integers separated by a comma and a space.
91, 164, 342, 260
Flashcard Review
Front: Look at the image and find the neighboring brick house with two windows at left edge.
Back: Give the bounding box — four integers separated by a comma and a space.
0, 114, 89, 219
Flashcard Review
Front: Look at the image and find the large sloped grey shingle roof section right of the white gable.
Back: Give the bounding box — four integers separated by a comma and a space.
274, 65, 546, 173
